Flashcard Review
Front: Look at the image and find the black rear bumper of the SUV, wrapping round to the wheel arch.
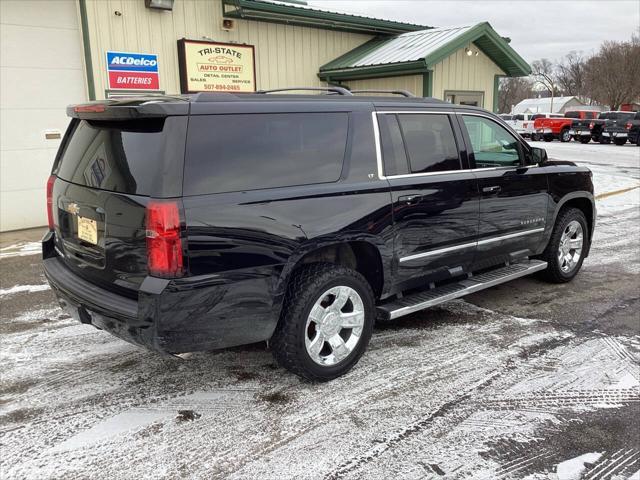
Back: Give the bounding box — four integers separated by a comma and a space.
42, 232, 281, 353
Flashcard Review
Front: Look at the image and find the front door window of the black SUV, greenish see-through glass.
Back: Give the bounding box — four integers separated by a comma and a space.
462, 115, 522, 168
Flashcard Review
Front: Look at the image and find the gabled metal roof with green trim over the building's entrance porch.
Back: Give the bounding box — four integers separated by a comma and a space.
318, 22, 531, 80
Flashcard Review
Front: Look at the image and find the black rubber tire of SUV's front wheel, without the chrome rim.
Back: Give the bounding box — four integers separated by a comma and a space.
540, 208, 591, 283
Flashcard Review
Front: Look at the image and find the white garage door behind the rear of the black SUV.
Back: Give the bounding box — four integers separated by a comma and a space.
0, 0, 86, 231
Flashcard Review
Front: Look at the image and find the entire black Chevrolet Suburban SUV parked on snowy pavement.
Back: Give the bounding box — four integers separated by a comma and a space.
43, 88, 595, 380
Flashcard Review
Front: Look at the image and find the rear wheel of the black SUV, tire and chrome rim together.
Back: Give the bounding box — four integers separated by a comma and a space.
271, 263, 375, 382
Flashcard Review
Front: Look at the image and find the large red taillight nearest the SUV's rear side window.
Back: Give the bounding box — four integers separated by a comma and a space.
147, 200, 184, 278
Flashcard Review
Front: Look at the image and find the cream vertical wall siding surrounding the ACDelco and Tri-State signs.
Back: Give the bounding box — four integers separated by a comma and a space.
82, 0, 371, 98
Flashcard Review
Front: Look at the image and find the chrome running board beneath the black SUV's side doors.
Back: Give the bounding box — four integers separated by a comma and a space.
377, 260, 547, 320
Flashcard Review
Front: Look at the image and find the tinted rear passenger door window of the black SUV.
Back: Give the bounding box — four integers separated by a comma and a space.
398, 114, 460, 173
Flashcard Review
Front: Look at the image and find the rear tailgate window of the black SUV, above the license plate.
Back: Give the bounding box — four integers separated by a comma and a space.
55, 119, 167, 195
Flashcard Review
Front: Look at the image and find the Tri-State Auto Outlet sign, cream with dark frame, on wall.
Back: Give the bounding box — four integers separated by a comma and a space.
178, 38, 256, 93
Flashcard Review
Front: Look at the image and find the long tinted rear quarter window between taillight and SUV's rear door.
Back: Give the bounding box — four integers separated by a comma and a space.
184, 113, 348, 195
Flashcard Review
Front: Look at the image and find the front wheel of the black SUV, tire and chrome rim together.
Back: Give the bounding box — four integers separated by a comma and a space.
540, 208, 589, 283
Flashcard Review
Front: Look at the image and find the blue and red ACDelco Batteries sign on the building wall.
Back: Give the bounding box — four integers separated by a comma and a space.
107, 52, 160, 90
